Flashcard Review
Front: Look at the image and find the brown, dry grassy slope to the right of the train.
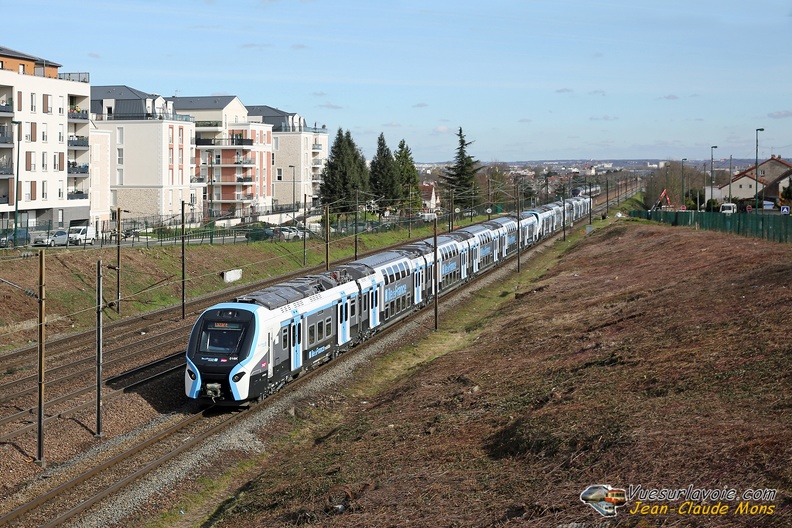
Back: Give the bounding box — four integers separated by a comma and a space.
204, 221, 792, 527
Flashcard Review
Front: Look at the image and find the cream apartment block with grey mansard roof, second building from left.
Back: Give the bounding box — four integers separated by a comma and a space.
91, 85, 198, 220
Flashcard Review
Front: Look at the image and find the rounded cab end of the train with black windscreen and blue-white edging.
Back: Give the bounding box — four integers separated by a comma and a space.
184, 303, 269, 405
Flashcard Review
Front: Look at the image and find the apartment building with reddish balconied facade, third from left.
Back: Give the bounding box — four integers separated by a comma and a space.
166, 96, 272, 220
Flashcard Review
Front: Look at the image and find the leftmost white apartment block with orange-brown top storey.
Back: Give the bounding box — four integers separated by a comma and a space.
0, 47, 93, 229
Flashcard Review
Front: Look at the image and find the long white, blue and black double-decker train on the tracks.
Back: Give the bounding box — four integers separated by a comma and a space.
184, 196, 591, 405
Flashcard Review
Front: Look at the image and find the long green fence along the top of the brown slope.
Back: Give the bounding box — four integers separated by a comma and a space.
630, 211, 792, 243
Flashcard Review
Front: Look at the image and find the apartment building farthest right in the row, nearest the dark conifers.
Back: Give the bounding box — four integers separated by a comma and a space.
247, 105, 329, 210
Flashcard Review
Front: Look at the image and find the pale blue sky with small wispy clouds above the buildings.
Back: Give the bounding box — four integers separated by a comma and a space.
6, 0, 792, 163
